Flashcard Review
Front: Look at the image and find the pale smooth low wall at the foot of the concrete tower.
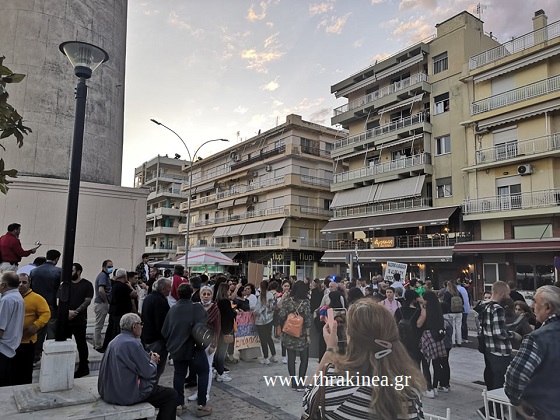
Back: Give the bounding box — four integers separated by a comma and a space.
0, 177, 148, 315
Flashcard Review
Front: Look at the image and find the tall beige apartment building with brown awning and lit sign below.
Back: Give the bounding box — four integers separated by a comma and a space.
323, 12, 498, 285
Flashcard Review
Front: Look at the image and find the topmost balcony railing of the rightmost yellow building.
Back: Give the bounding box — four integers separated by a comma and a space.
469, 21, 560, 70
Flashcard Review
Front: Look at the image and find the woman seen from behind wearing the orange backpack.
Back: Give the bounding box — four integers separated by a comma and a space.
279, 281, 311, 391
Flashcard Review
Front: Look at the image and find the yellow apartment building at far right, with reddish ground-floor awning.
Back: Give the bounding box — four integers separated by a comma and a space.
454, 10, 560, 290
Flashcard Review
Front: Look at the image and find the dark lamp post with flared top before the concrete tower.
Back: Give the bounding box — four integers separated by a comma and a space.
55, 41, 109, 341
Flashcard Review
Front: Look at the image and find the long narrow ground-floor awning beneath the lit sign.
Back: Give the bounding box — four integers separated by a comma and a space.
321, 246, 453, 263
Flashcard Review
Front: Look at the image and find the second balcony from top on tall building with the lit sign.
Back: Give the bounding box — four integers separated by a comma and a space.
331, 112, 431, 157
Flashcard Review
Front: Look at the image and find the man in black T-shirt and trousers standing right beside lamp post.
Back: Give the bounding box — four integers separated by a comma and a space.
66, 263, 93, 378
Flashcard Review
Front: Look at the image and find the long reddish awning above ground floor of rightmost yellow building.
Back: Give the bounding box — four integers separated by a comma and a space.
453, 239, 560, 254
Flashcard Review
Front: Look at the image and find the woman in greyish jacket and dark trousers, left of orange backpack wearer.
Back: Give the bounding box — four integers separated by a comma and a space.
253, 280, 278, 365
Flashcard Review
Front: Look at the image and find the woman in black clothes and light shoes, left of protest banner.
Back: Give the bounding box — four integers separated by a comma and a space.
214, 278, 237, 382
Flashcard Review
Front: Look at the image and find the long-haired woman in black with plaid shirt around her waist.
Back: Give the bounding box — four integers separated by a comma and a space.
417, 291, 450, 398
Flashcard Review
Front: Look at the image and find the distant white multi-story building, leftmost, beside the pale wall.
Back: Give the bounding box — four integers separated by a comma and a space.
134, 155, 187, 260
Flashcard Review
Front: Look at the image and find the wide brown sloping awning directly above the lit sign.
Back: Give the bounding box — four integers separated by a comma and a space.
321, 207, 458, 233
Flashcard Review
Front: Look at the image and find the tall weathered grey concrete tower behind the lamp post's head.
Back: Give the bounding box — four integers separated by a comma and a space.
0, 0, 127, 185
